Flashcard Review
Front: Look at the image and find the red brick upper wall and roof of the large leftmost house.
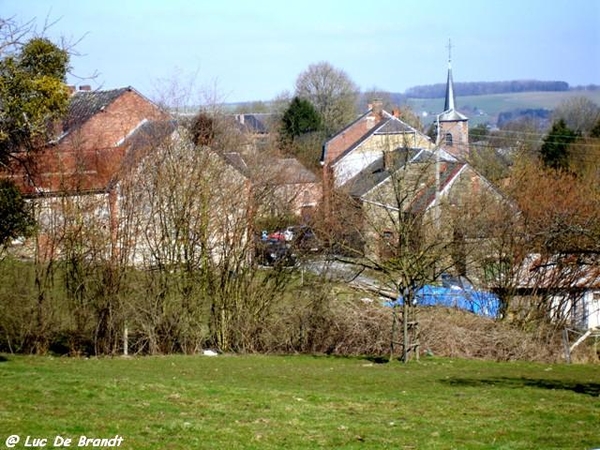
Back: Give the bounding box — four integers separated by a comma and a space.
10, 87, 169, 197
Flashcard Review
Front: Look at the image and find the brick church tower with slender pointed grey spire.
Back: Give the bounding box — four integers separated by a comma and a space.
437, 42, 469, 159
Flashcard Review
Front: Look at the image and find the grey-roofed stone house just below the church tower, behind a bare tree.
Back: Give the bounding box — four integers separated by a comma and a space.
344, 149, 503, 262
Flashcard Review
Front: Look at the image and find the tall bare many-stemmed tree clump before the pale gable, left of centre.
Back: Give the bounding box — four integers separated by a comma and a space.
116, 118, 292, 353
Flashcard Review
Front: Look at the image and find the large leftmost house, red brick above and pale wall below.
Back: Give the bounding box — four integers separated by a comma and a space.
3, 87, 169, 259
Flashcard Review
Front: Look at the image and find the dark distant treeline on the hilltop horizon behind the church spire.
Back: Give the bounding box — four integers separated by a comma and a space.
404, 80, 569, 98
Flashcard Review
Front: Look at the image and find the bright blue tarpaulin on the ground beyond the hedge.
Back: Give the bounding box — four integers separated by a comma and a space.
387, 284, 500, 317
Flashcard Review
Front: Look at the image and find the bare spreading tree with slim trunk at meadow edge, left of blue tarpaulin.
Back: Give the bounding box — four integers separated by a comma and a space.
326, 148, 453, 362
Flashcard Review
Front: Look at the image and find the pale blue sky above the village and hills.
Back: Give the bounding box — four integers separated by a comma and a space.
0, 0, 600, 102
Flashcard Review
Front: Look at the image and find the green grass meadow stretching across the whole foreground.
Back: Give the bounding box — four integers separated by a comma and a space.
0, 355, 600, 449
